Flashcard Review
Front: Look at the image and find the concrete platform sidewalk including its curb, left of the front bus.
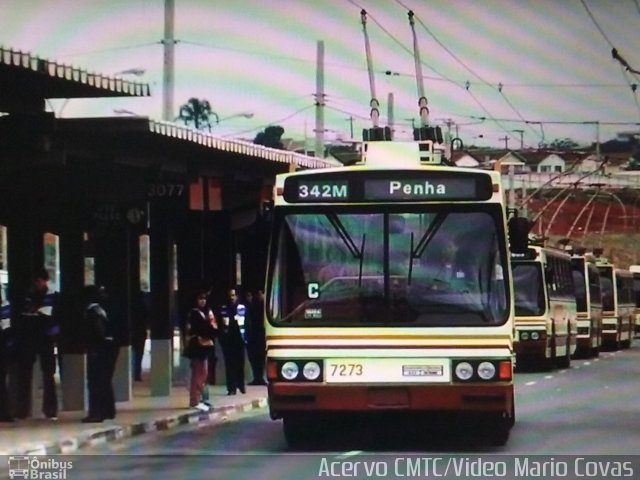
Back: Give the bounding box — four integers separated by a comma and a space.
0, 382, 267, 455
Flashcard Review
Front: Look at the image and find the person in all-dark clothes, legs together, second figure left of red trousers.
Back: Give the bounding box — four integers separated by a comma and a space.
82, 285, 119, 423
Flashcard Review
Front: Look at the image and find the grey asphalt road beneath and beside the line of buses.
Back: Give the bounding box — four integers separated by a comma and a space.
2, 342, 640, 480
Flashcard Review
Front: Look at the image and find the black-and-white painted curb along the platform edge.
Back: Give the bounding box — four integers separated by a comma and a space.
2, 398, 267, 455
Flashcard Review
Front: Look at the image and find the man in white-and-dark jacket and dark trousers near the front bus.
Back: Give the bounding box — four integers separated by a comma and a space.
220, 288, 247, 395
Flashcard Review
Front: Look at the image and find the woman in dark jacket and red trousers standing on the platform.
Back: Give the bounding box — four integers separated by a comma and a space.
184, 290, 218, 412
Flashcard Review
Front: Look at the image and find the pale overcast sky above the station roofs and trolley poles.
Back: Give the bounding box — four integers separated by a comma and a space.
0, 0, 640, 147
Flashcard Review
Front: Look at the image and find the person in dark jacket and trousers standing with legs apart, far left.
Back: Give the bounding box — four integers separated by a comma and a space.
16, 268, 60, 420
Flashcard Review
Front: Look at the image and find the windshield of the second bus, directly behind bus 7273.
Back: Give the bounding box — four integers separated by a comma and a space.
511, 262, 545, 317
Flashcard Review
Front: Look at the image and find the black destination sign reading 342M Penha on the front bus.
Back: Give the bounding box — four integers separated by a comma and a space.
283, 170, 493, 203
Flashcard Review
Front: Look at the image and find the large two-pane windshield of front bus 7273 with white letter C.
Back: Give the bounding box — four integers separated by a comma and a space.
268, 205, 509, 326
